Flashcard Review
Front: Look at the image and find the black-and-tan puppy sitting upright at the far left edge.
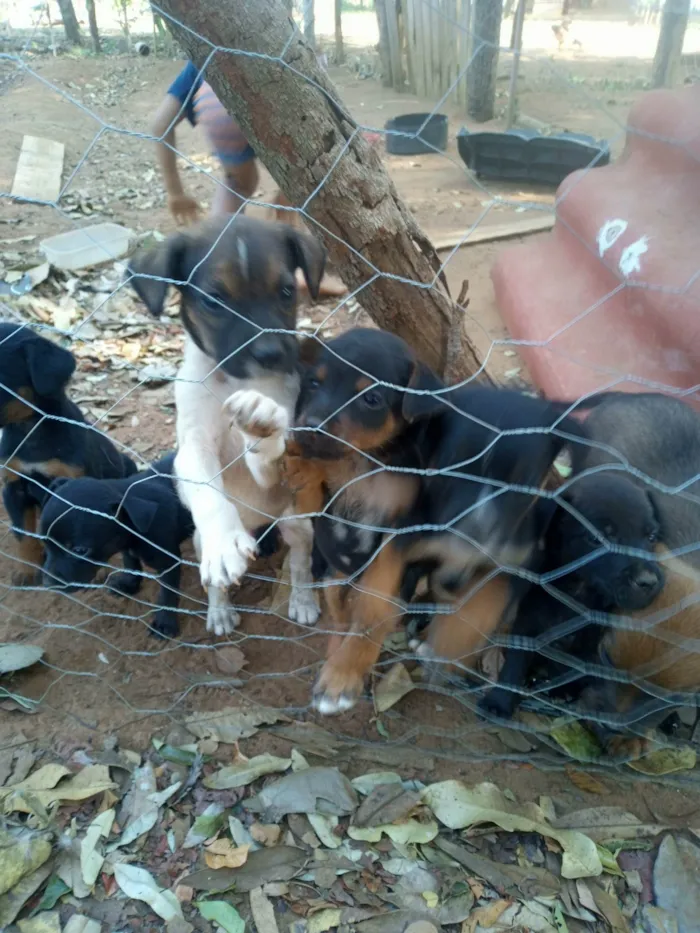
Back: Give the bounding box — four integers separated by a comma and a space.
0, 322, 136, 585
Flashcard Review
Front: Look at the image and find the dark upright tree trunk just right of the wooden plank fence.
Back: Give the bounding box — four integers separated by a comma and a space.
467, 0, 503, 123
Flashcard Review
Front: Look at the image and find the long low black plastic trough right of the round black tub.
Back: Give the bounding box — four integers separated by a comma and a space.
457, 129, 610, 187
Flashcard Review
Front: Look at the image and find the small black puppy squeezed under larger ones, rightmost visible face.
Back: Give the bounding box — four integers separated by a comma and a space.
480, 473, 664, 718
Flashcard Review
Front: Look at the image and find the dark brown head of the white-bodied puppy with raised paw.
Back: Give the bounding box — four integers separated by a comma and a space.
129, 217, 326, 379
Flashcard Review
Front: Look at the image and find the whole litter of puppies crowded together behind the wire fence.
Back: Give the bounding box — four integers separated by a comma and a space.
0, 218, 700, 772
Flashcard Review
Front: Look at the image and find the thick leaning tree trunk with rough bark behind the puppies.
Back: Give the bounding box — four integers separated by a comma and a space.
159, 0, 480, 377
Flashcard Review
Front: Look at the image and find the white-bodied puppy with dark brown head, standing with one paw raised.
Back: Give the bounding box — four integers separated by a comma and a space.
130, 217, 326, 635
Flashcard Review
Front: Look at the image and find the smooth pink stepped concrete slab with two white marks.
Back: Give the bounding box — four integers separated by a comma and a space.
492, 86, 700, 398
